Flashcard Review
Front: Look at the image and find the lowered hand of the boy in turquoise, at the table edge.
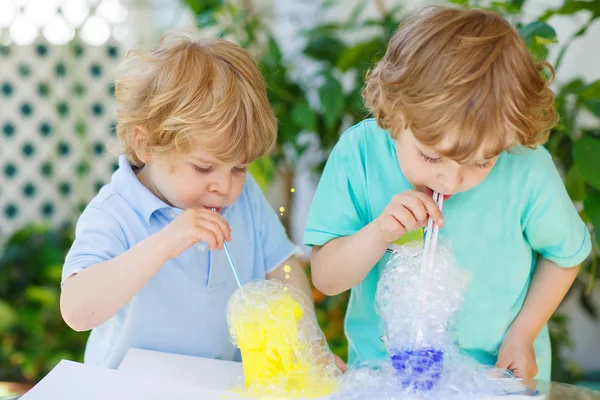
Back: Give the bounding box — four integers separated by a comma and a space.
496, 331, 538, 379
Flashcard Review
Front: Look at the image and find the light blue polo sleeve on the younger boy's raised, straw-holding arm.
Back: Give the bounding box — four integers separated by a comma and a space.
61, 206, 128, 287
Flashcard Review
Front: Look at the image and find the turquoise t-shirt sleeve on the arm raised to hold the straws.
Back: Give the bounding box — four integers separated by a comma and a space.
304, 128, 367, 246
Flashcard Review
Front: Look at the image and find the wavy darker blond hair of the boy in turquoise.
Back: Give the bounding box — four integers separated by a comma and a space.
363, 6, 558, 162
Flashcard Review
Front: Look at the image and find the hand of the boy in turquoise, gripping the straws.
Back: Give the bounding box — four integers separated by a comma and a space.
375, 190, 444, 243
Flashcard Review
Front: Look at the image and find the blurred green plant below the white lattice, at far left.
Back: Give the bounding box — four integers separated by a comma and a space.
0, 226, 87, 383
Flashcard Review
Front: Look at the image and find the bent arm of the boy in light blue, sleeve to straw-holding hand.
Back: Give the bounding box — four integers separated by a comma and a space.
60, 208, 231, 331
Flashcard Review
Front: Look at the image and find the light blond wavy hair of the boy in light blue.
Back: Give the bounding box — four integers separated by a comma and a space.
115, 30, 277, 167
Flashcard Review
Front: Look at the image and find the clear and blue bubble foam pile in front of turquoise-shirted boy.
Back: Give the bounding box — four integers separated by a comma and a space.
331, 240, 529, 400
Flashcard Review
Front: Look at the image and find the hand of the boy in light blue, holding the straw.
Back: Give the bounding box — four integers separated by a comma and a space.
159, 208, 231, 258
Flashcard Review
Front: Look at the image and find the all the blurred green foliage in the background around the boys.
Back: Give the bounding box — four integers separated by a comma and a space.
0, 0, 600, 382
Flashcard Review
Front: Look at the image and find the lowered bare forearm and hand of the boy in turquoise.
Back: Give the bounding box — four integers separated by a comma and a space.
496, 258, 579, 378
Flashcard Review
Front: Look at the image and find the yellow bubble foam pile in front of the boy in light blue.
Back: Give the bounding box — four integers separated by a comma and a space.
227, 280, 341, 399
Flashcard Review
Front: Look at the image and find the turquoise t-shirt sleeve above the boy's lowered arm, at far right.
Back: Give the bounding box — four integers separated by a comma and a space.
524, 148, 592, 268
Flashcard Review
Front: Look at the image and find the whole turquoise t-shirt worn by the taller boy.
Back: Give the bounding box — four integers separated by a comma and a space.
304, 119, 591, 379
